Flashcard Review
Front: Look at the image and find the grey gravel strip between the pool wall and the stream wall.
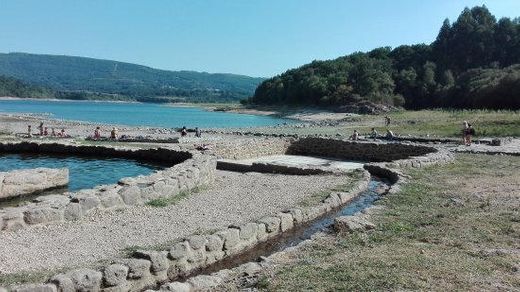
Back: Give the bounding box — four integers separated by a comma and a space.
0, 171, 352, 274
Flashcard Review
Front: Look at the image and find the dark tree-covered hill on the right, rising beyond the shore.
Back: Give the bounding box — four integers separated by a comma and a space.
249, 6, 520, 109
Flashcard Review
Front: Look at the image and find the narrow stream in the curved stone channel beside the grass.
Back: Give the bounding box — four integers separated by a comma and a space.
176, 176, 390, 281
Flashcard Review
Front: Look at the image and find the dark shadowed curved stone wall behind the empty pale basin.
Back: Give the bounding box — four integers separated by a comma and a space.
286, 138, 437, 162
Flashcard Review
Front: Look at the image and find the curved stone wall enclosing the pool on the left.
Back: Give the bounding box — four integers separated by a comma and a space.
0, 143, 216, 230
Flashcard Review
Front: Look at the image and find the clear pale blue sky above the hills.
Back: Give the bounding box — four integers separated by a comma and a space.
0, 0, 520, 77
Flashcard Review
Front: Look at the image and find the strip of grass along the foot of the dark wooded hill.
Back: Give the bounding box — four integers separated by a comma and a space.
245, 110, 520, 137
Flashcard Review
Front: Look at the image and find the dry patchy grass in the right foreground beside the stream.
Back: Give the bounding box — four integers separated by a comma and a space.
259, 154, 520, 291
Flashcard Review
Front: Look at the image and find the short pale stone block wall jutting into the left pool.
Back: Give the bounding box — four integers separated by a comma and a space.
0, 167, 69, 200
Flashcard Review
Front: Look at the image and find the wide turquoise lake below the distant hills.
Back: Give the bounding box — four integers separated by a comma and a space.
0, 100, 293, 128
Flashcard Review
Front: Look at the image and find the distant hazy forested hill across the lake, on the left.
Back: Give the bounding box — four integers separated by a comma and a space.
0, 53, 263, 101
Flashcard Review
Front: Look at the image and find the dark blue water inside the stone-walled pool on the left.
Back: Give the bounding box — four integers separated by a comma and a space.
0, 154, 162, 191
